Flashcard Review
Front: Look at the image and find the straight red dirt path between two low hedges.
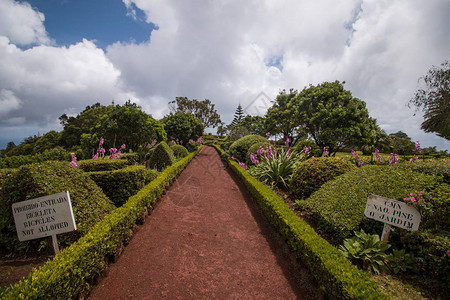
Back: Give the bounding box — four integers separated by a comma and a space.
90, 146, 317, 299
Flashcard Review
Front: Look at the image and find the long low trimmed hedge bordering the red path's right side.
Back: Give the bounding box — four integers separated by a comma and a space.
215, 146, 387, 299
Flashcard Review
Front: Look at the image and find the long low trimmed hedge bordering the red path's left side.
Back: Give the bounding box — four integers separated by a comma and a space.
2, 146, 198, 299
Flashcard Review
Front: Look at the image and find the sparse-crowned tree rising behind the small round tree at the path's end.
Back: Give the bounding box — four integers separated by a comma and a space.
169, 97, 222, 128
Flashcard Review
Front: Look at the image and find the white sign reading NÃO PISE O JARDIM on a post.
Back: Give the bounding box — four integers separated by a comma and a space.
364, 194, 420, 231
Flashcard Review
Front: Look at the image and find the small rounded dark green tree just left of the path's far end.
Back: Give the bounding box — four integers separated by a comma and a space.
161, 112, 205, 144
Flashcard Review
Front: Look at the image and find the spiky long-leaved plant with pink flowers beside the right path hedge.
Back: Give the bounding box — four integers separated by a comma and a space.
246, 140, 305, 190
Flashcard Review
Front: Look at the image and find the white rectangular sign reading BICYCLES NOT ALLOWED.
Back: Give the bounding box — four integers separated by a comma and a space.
12, 191, 77, 241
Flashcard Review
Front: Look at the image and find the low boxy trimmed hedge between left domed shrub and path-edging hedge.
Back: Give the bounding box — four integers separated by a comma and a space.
88, 166, 158, 207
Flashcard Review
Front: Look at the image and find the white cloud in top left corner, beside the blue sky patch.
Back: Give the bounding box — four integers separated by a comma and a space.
0, 0, 50, 46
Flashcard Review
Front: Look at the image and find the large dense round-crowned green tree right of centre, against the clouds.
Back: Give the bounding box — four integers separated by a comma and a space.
292, 81, 376, 155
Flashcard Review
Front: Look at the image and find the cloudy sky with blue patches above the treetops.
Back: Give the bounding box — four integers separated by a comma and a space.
0, 0, 450, 150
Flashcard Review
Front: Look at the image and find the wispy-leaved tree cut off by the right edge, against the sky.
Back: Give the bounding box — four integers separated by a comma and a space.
409, 60, 450, 140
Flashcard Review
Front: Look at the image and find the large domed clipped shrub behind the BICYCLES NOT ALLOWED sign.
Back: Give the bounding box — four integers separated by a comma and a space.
0, 161, 115, 252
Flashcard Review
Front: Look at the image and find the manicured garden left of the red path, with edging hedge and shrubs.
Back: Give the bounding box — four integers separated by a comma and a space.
0, 139, 200, 299
